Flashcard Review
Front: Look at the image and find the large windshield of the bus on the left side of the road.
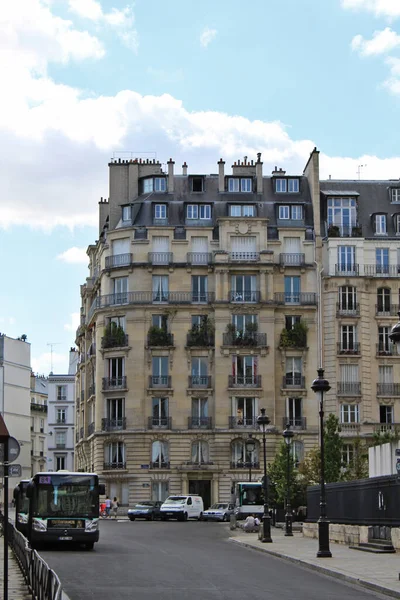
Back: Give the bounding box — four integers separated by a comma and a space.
33, 474, 98, 517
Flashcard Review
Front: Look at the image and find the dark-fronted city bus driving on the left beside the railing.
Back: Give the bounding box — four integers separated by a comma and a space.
26, 471, 105, 549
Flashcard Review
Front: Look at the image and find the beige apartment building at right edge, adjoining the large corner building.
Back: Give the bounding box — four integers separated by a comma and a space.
320, 179, 400, 461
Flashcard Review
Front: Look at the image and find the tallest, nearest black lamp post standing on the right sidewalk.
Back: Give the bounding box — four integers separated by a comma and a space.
311, 368, 332, 558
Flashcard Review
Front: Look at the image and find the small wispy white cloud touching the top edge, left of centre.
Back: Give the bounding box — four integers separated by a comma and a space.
68, 0, 139, 52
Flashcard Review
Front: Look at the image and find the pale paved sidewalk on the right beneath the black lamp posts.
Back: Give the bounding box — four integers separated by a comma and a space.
230, 527, 400, 598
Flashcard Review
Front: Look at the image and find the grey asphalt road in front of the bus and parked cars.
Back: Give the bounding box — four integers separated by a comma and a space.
40, 520, 383, 600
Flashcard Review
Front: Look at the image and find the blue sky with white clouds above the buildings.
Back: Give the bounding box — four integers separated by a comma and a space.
0, 0, 400, 375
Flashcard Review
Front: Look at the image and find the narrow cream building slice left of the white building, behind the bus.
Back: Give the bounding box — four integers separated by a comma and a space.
31, 373, 48, 476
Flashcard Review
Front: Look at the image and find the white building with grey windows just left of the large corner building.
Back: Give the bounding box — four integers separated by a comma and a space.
47, 348, 78, 471
